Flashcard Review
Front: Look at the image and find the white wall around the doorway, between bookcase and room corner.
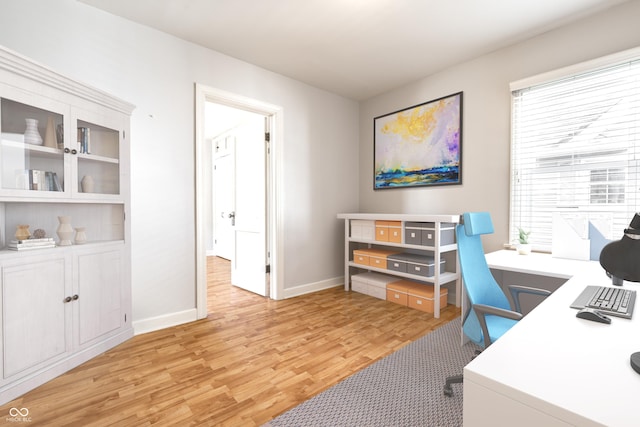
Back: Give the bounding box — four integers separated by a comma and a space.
0, 0, 358, 332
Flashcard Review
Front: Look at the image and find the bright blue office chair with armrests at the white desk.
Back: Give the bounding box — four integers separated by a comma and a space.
444, 212, 551, 396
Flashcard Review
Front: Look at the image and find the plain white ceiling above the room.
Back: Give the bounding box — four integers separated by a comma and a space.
78, 0, 628, 100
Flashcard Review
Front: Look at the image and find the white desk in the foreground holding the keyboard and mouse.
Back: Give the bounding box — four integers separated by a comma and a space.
464, 254, 640, 427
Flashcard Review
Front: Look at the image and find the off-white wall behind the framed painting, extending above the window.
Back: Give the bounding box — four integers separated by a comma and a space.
359, 1, 640, 250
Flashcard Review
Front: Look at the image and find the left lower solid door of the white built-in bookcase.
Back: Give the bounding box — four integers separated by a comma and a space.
1, 257, 71, 380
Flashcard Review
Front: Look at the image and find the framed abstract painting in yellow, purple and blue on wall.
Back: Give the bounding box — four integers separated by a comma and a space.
373, 91, 463, 190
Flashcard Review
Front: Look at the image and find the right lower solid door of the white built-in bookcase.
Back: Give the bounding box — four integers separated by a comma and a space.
74, 248, 125, 347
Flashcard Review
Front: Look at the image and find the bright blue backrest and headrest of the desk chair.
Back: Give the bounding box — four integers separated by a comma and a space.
456, 212, 511, 345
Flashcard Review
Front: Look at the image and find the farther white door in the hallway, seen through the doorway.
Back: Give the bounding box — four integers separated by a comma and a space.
213, 135, 236, 260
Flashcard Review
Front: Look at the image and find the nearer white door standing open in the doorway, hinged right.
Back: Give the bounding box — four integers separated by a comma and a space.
231, 113, 269, 296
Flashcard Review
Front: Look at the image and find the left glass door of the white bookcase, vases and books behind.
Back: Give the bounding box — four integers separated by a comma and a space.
0, 98, 65, 196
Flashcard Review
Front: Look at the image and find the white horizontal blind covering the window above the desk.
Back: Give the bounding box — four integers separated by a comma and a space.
510, 58, 640, 251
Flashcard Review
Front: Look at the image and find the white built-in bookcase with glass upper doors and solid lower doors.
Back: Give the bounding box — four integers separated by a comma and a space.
0, 48, 133, 404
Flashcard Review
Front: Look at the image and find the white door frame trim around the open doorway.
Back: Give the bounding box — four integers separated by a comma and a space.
195, 83, 284, 319
